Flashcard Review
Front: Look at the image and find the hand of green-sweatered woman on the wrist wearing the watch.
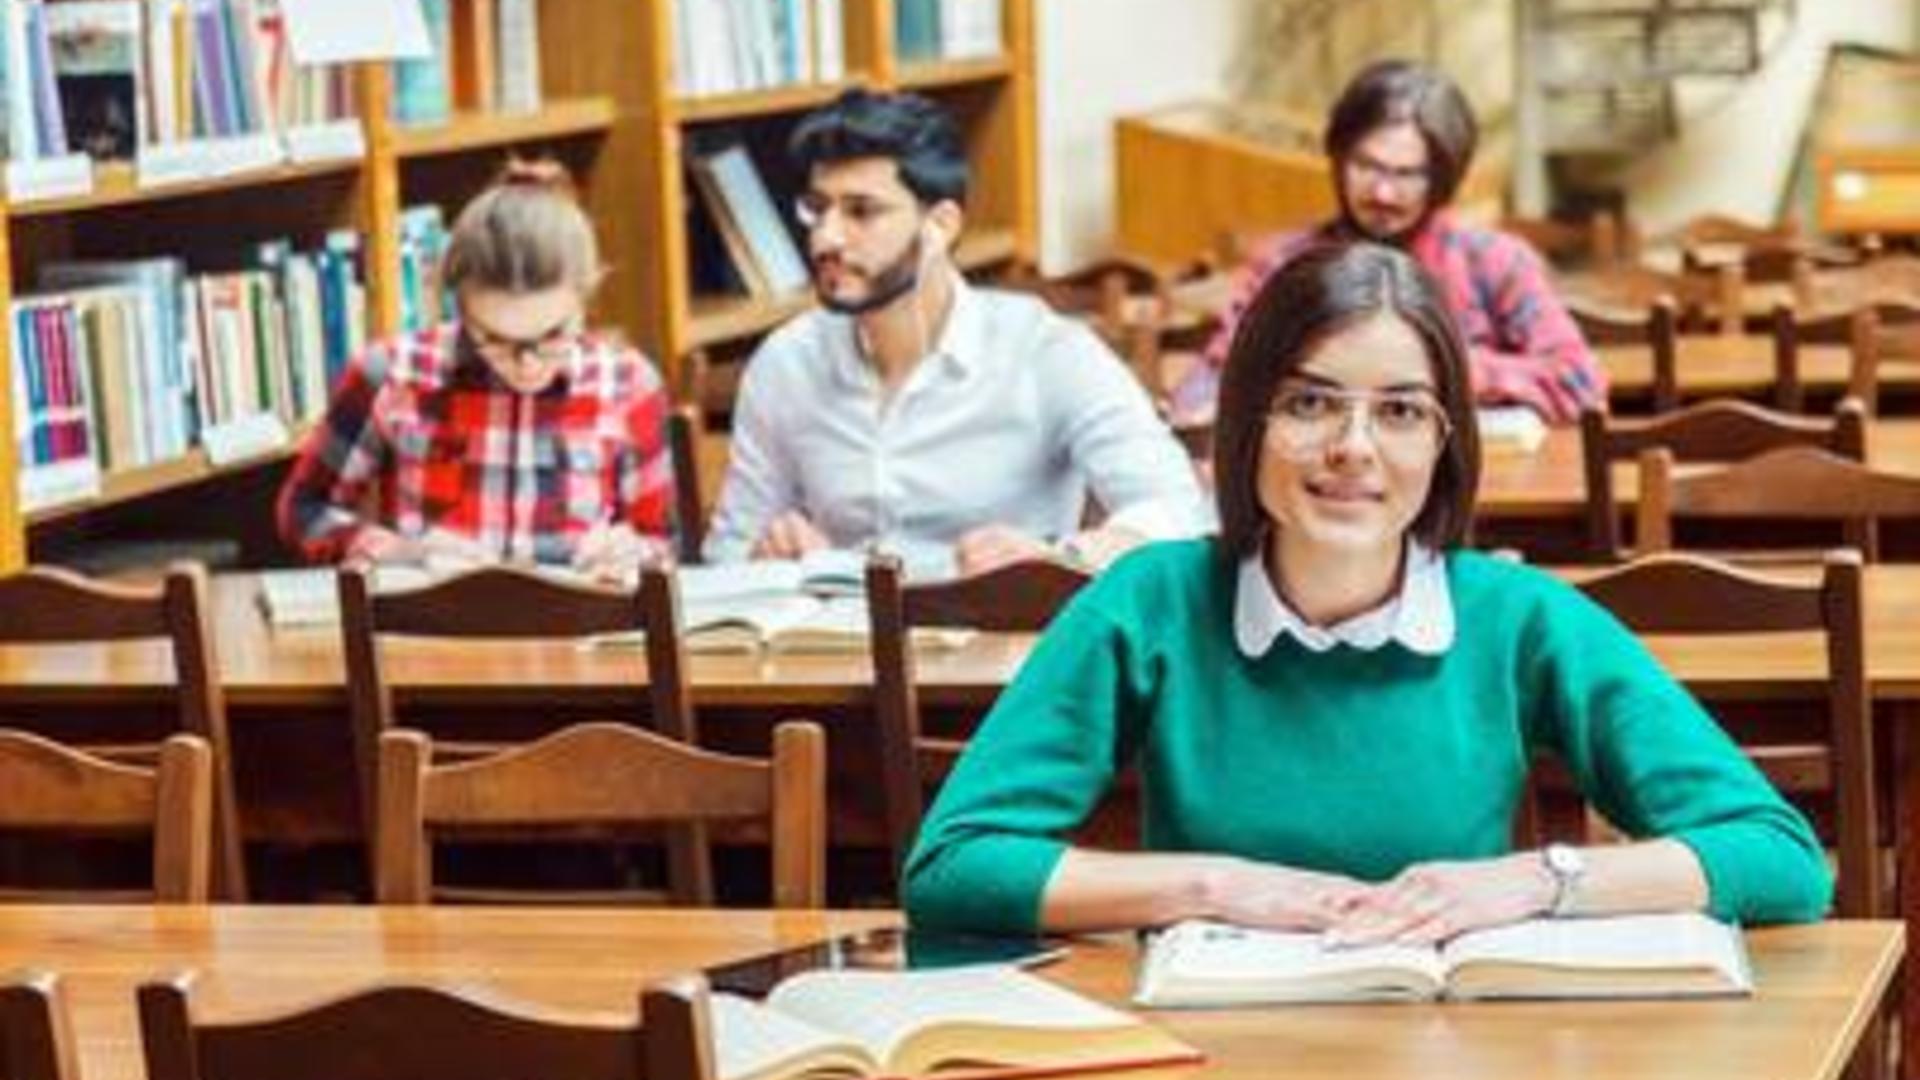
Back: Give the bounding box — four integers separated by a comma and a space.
1327, 851, 1555, 945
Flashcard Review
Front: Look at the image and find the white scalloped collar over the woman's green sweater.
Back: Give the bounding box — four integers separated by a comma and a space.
1233, 540, 1453, 659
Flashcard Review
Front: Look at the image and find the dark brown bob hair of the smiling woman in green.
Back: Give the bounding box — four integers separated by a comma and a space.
1213, 242, 1480, 561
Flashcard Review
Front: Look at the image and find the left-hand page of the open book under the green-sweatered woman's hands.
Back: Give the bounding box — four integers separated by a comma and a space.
1135, 920, 1444, 1005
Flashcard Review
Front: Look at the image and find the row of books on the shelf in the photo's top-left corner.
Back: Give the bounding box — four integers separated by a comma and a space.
4, 0, 353, 160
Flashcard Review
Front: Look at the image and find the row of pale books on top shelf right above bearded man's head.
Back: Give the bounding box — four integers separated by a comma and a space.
674, 0, 848, 96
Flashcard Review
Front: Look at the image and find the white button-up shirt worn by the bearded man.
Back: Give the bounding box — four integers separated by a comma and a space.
707, 282, 1208, 561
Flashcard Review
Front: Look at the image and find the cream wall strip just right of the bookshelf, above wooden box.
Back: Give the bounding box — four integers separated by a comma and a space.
1037, 0, 1246, 271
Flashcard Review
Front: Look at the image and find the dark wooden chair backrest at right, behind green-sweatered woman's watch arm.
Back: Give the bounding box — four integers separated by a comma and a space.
1580, 552, 1884, 919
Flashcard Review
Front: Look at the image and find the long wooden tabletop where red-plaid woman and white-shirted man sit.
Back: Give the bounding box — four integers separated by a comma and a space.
0, 563, 1920, 709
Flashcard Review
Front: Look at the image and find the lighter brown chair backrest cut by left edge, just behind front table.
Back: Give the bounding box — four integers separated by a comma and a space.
0, 730, 213, 903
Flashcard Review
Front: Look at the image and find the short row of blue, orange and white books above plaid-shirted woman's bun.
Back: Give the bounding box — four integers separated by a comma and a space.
394, 0, 541, 125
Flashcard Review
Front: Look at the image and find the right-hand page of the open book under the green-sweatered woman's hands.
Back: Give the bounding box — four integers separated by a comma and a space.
1442, 913, 1751, 994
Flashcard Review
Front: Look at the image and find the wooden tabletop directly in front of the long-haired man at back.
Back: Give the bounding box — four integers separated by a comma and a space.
1475, 417, 1920, 519
